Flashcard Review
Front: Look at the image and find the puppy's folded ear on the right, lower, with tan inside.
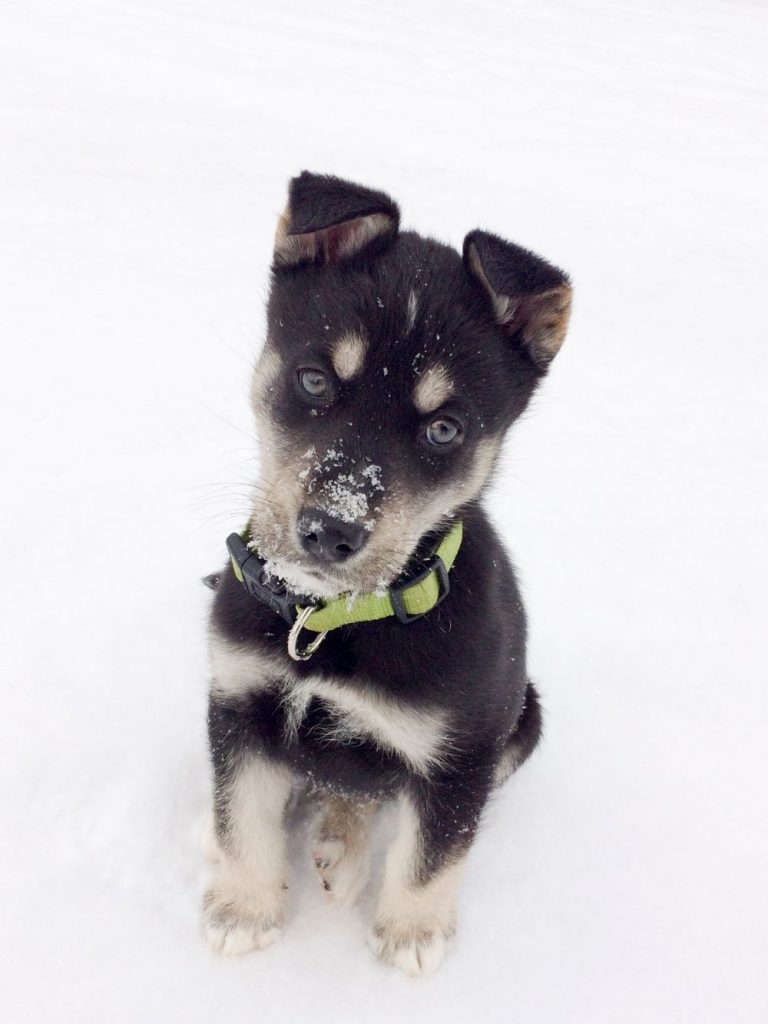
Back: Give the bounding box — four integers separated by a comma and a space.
464, 231, 571, 372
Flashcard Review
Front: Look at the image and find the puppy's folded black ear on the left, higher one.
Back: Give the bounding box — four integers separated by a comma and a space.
274, 171, 400, 267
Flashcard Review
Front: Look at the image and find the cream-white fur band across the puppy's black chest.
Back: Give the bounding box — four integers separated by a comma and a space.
211, 642, 450, 774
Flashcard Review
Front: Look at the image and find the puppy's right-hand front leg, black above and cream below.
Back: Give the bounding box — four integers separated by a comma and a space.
371, 772, 489, 975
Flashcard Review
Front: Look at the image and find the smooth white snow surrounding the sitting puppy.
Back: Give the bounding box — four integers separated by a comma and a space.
0, 0, 768, 1024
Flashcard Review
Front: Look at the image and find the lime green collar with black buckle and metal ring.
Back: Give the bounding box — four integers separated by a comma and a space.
226, 521, 463, 660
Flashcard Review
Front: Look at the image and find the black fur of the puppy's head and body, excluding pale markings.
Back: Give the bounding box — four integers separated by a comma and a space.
209, 174, 566, 882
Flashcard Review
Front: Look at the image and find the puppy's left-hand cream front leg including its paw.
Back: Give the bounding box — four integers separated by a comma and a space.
203, 713, 291, 955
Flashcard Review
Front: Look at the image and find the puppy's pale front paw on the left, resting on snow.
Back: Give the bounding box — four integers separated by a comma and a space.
203, 887, 283, 956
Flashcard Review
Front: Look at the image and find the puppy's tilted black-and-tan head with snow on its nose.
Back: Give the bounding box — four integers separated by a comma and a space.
246, 173, 570, 597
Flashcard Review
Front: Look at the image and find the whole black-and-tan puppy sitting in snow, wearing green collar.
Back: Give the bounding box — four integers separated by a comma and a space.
205, 173, 570, 973
